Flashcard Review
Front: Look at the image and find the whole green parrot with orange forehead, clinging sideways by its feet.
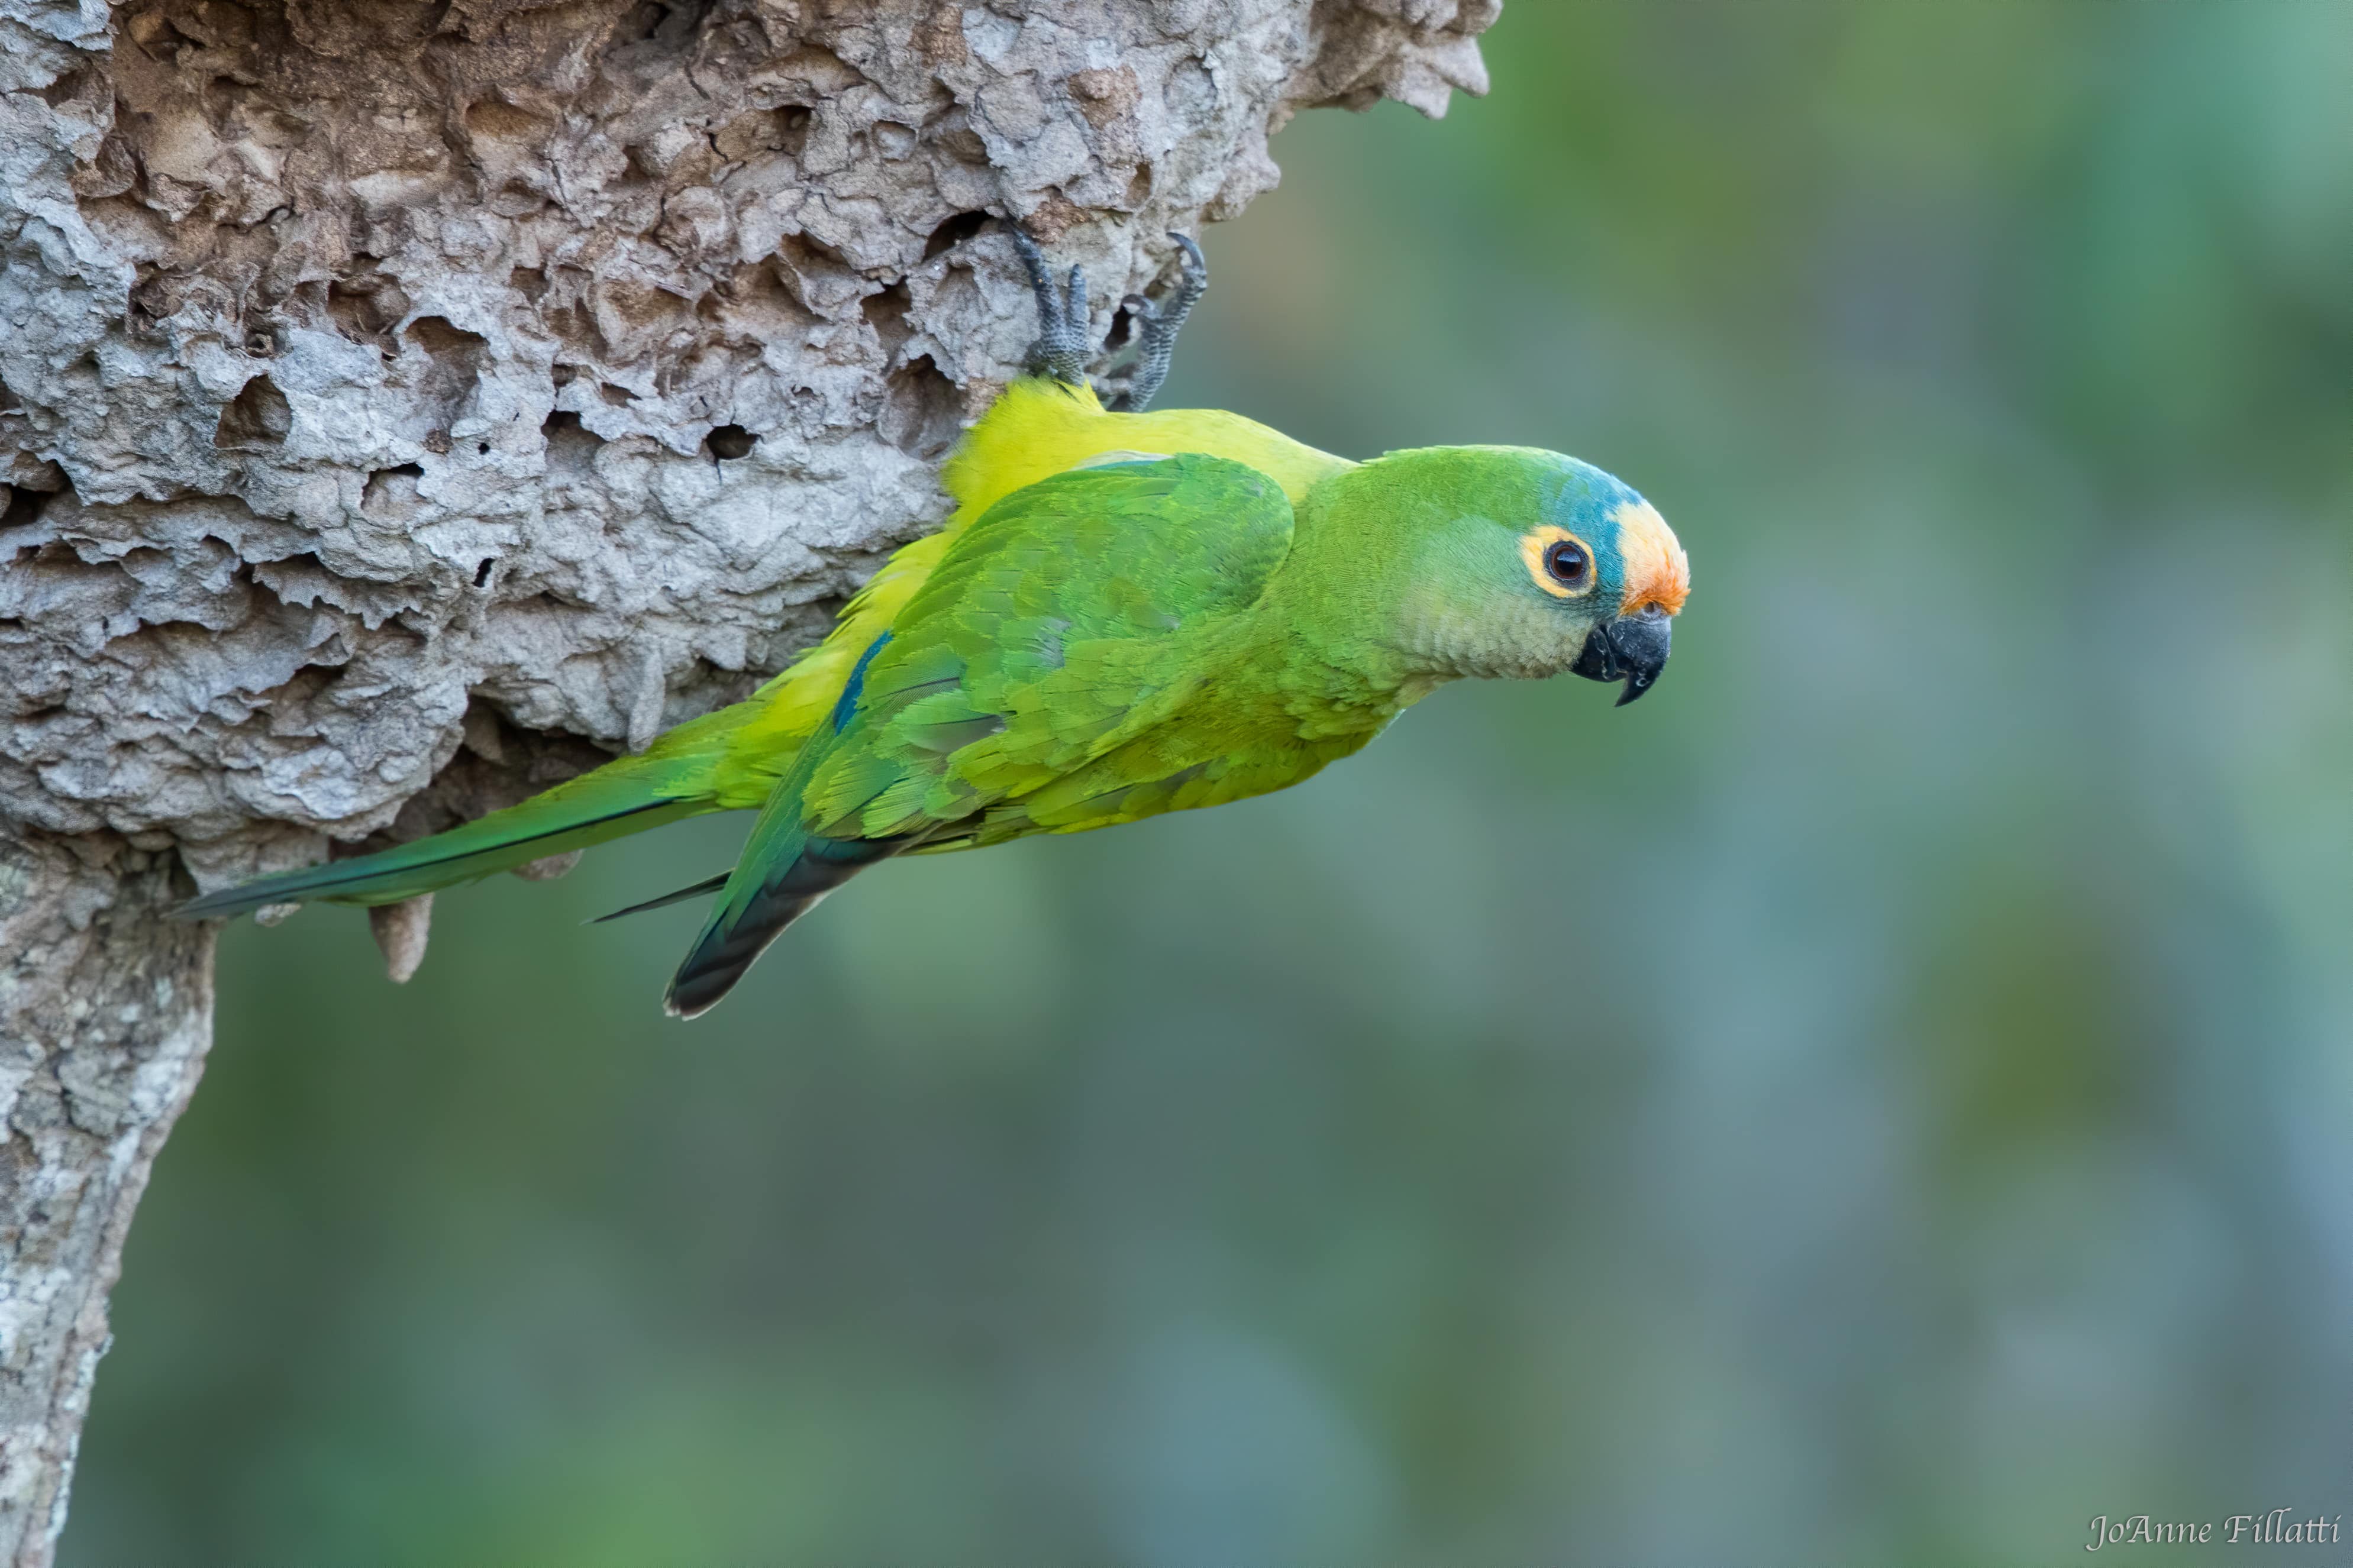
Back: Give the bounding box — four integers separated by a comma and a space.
181, 232, 1689, 1018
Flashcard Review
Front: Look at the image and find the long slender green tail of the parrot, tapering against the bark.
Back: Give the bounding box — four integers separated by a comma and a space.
176, 710, 730, 919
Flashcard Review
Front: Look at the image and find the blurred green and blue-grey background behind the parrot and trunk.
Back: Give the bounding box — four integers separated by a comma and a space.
63, 0, 2353, 1568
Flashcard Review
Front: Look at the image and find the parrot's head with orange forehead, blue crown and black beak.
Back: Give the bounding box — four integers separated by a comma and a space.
1315, 447, 1692, 707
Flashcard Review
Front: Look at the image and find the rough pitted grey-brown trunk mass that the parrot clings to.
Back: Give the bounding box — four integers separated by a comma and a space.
0, 0, 1499, 1561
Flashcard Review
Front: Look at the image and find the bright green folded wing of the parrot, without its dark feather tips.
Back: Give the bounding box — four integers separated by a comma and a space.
800, 454, 1292, 846
